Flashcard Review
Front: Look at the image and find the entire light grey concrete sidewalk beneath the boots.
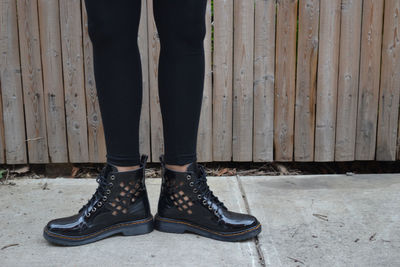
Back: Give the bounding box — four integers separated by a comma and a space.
0, 174, 400, 266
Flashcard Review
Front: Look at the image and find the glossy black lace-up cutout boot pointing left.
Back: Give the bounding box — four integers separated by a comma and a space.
43, 155, 153, 246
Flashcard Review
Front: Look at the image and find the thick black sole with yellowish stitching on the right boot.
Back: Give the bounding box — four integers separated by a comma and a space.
154, 214, 261, 242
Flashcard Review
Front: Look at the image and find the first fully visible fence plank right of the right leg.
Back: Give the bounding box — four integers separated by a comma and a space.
212, 0, 233, 161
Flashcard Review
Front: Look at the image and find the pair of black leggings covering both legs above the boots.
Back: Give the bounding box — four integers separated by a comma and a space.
85, 0, 207, 166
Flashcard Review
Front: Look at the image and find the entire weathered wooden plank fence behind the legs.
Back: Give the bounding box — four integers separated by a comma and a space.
0, 0, 400, 164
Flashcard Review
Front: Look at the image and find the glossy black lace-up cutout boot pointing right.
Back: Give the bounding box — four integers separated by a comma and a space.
154, 155, 261, 241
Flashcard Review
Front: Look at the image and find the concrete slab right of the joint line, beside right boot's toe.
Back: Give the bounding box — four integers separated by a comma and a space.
239, 174, 400, 266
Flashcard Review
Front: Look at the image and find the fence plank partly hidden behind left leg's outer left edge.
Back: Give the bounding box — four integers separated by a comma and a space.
81, 1, 107, 162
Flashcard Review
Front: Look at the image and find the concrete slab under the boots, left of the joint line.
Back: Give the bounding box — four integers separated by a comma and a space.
0, 177, 259, 266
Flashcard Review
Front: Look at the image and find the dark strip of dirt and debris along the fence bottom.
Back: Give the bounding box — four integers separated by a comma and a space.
0, 161, 400, 184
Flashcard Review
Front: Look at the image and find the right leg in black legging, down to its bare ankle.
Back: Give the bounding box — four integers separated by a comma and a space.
153, 0, 207, 170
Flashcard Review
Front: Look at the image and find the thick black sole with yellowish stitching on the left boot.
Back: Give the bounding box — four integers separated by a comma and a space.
43, 216, 154, 246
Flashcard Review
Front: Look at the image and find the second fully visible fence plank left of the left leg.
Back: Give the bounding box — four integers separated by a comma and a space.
38, 0, 68, 163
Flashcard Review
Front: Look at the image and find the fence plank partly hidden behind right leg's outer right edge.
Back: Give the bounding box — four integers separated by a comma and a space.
196, 0, 212, 162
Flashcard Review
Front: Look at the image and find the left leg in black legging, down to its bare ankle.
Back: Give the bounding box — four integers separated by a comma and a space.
85, 0, 142, 171
